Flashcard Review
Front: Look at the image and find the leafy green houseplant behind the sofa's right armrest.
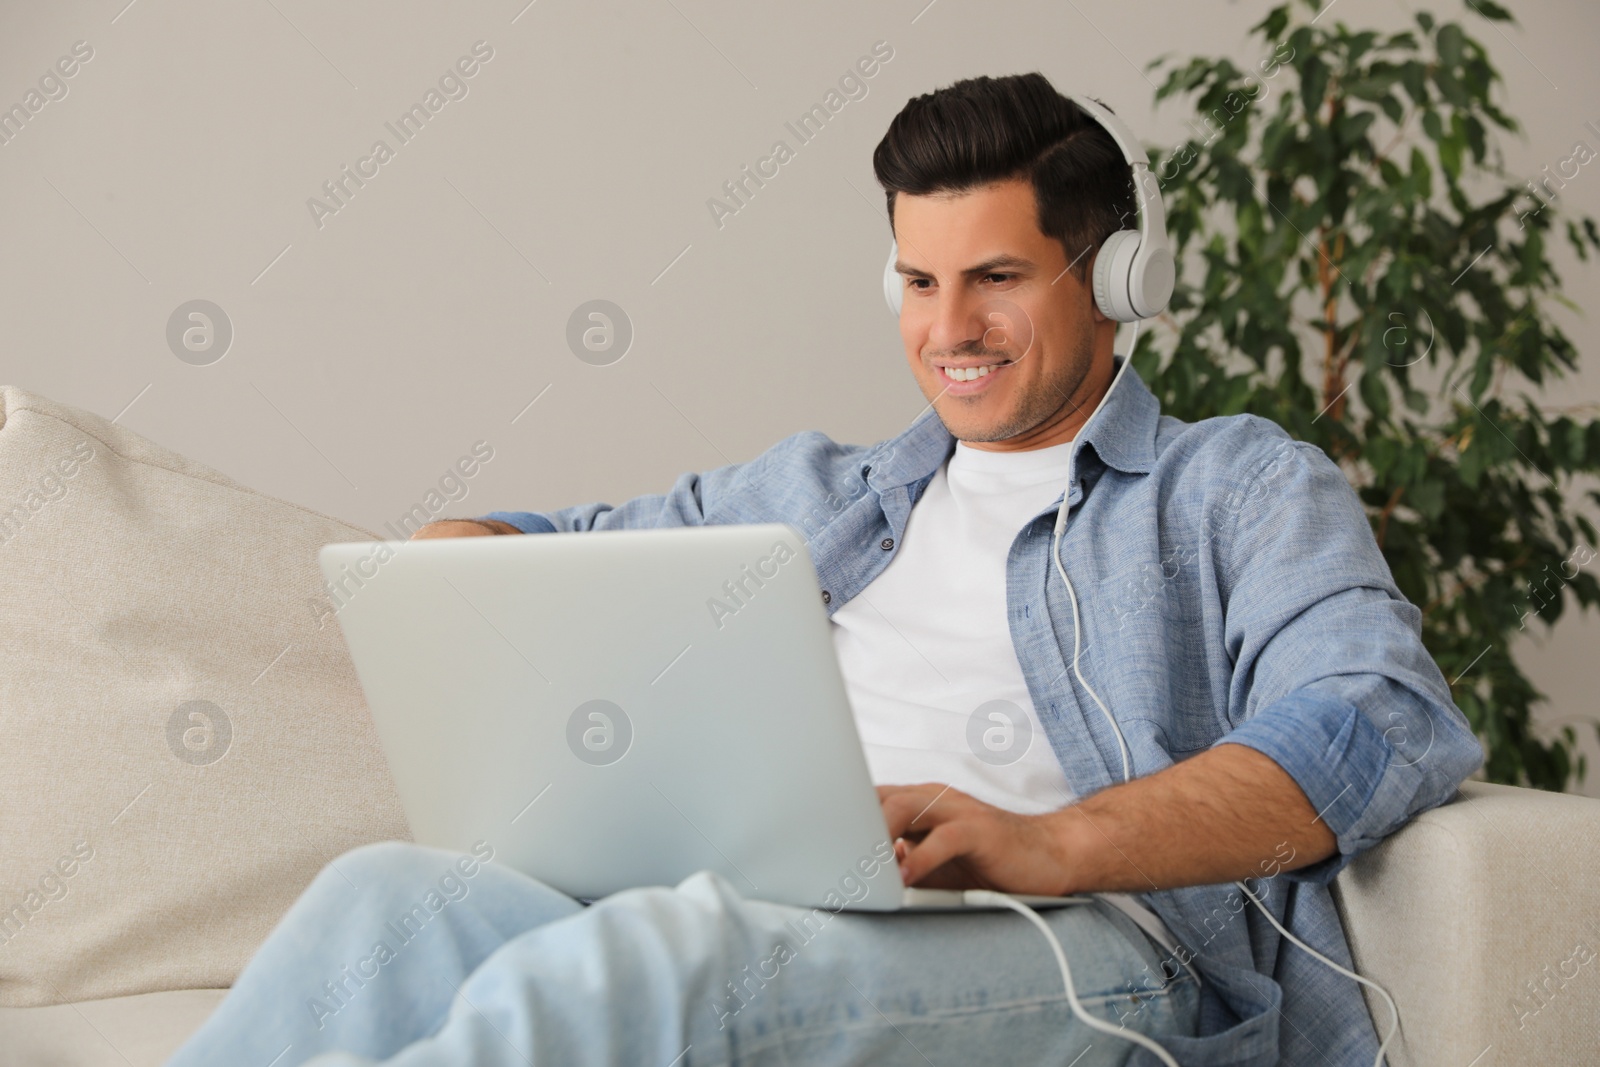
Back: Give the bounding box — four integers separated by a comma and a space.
1134, 0, 1600, 789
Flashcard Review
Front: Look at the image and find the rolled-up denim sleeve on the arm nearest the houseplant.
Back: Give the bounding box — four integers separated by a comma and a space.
1218, 445, 1483, 883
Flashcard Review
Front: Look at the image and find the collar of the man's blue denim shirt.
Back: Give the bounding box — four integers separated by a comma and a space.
870, 357, 1162, 490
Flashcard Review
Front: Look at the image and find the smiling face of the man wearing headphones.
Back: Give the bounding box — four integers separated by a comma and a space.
894, 179, 1117, 451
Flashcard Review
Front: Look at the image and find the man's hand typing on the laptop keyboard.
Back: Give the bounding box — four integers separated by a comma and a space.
878, 782, 1070, 896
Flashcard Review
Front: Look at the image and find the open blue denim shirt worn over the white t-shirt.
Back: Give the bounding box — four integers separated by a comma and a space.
486, 361, 1483, 1067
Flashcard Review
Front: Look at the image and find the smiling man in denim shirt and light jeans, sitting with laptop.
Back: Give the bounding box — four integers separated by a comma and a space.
173, 74, 1482, 1067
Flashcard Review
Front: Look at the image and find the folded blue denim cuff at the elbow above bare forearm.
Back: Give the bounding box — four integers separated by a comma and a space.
1218, 689, 1422, 885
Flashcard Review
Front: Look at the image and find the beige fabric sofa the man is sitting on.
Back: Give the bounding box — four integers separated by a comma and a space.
0, 387, 1600, 1067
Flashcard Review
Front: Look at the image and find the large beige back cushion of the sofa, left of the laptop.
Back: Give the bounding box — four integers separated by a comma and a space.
0, 387, 410, 1006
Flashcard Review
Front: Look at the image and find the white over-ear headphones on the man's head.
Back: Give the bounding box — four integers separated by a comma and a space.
883, 96, 1174, 322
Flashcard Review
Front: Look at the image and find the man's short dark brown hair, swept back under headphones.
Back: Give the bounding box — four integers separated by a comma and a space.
872, 72, 1136, 282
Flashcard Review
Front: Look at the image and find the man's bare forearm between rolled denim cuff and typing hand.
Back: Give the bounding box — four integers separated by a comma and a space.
1048, 744, 1338, 893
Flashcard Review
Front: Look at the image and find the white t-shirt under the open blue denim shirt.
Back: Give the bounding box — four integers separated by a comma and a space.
832, 442, 1170, 939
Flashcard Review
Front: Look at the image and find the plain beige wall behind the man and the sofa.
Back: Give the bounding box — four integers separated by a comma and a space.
0, 0, 1600, 792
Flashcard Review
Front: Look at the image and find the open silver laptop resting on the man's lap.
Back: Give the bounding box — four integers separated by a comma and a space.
318, 523, 1091, 912
